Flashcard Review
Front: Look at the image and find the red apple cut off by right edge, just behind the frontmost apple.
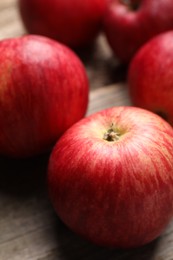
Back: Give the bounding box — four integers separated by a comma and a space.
128, 31, 173, 125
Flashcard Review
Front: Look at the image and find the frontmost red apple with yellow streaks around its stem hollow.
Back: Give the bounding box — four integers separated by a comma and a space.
48, 107, 173, 248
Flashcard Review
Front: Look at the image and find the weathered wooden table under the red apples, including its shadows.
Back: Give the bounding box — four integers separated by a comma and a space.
0, 0, 173, 260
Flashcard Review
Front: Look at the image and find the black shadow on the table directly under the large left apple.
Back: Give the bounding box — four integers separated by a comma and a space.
0, 154, 49, 197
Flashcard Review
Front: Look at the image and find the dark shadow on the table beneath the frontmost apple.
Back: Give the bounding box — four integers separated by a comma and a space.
46, 216, 159, 260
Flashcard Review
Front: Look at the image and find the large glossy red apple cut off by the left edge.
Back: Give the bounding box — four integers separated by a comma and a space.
0, 35, 89, 157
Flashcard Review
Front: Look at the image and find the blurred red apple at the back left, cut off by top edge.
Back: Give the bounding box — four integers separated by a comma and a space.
19, 0, 107, 48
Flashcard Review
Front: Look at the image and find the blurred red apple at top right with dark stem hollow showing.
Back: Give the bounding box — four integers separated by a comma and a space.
103, 0, 173, 63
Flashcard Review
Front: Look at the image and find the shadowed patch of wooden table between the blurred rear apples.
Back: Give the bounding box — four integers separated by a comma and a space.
74, 35, 128, 88
